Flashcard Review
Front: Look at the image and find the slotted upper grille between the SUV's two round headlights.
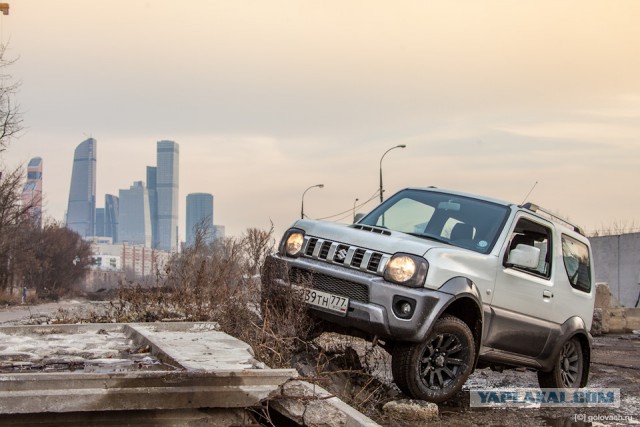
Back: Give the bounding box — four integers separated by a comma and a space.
302, 236, 391, 276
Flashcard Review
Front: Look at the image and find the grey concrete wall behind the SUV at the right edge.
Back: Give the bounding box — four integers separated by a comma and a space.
589, 233, 640, 307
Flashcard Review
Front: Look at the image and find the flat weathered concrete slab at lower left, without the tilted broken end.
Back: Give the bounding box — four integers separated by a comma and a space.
0, 323, 297, 414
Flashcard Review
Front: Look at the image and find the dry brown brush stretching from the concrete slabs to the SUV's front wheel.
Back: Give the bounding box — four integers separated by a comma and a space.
108, 229, 393, 418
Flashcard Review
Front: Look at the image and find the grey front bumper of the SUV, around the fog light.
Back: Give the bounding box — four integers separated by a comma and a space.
262, 254, 454, 342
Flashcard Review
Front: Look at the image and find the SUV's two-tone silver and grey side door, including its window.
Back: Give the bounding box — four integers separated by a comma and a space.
484, 216, 555, 357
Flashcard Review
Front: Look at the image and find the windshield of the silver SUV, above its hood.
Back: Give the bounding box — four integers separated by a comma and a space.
358, 190, 509, 253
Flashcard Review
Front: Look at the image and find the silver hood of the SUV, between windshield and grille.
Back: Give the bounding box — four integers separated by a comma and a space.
292, 220, 453, 256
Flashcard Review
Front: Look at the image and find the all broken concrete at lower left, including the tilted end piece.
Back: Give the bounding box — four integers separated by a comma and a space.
0, 322, 377, 427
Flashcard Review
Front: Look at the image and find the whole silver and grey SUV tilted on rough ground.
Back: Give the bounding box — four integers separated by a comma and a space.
262, 188, 595, 402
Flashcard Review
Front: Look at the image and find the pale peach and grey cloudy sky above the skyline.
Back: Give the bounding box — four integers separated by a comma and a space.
0, 0, 640, 239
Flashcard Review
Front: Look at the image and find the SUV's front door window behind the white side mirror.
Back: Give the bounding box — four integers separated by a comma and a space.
505, 218, 553, 278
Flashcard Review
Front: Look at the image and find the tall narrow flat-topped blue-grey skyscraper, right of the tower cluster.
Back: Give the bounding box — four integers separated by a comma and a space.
158, 141, 180, 252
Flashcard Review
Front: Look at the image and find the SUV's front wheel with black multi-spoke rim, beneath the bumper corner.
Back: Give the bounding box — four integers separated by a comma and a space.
391, 316, 476, 403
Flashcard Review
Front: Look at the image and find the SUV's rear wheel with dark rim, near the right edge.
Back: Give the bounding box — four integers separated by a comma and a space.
538, 338, 587, 388
